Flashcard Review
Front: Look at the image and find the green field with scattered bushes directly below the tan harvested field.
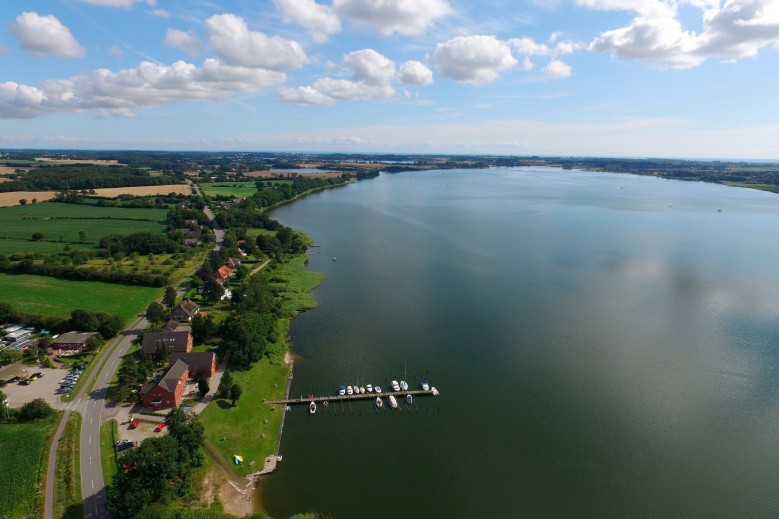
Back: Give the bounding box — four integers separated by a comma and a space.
0, 202, 167, 254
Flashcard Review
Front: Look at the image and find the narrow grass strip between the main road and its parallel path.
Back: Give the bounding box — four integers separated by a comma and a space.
54, 413, 84, 519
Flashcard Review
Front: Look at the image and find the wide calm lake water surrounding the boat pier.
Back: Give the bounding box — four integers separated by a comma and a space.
262, 168, 779, 519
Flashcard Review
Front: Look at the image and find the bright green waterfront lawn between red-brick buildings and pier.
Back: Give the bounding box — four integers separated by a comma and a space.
200, 338, 289, 475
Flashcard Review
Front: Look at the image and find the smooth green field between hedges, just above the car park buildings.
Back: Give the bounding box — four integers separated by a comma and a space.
0, 274, 164, 322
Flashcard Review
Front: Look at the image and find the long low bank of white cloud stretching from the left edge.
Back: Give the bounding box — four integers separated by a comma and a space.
0, 59, 286, 118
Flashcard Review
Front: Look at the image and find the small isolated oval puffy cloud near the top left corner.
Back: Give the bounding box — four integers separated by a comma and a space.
10, 12, 85, 58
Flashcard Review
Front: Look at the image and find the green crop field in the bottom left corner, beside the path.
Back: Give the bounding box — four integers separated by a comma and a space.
0, 413, 62, 519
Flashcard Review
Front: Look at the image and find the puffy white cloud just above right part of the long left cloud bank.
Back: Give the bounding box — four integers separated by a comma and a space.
205, 14, 309, 71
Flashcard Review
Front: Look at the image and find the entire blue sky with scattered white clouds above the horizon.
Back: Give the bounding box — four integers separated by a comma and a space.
0, 0, 779, 160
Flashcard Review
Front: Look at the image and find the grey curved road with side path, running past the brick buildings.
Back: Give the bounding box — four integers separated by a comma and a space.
44, 190, 224, 519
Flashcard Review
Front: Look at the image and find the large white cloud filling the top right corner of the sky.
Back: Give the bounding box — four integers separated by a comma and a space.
578, 0, 779, 68
